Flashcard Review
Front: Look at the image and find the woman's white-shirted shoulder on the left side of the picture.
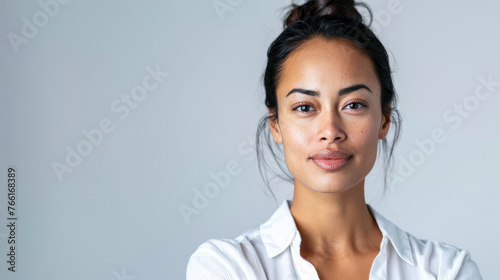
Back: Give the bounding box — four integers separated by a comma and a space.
186, 229, 265, 280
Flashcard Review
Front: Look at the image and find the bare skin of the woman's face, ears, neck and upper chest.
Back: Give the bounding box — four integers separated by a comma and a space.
269, 37, 390, 279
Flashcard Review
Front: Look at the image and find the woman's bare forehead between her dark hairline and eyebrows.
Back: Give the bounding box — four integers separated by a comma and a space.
277, 38, 380, 95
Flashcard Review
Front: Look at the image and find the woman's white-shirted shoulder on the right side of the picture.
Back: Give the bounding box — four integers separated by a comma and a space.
408, 233, 482, 280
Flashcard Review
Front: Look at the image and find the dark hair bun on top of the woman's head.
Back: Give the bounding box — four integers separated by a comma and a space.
284, 0, 364, 28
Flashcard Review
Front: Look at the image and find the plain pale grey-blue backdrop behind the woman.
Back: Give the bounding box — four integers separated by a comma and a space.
0, 0, 500, 280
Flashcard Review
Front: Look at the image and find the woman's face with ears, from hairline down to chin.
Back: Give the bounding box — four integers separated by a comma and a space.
269, 38, 390, 192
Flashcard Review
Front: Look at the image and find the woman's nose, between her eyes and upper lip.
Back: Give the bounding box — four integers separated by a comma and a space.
318, 110, 347, 143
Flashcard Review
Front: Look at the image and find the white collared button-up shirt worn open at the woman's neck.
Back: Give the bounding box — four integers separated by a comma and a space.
186, 200, 483, 280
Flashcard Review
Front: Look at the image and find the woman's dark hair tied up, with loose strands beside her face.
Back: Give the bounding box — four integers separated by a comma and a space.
255, 0, 401, 203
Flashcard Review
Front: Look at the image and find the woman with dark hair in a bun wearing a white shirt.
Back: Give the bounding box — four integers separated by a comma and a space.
187, 1, 482, 280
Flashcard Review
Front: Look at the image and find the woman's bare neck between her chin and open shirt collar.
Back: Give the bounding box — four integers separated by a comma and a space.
290, 180, 382, 256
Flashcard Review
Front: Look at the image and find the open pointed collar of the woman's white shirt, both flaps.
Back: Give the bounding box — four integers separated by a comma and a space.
260, 199, 414, 265
